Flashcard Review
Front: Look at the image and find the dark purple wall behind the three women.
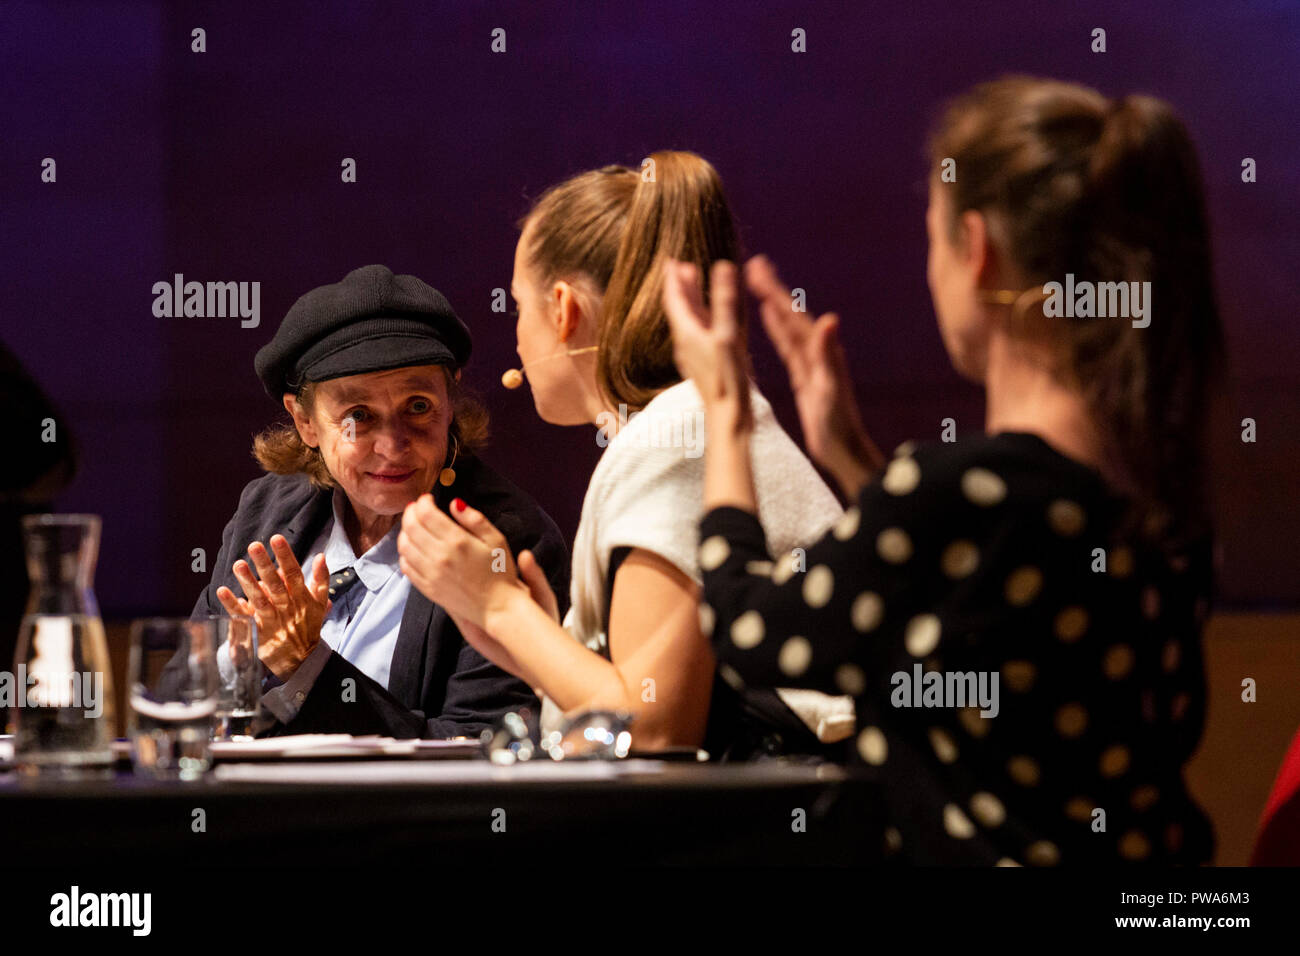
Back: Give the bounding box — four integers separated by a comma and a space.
0, 0, 1300, 615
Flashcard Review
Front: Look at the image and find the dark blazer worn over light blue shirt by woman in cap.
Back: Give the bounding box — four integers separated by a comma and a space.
194, 455, 569, 737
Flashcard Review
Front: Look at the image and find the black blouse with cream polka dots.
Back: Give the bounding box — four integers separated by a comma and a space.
699, 432, 1213, 866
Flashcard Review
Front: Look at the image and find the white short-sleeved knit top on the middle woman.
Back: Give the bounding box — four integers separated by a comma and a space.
541, 380, 853, 740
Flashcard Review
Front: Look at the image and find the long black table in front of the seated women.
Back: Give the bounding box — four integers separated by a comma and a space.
0, 760, 881, 866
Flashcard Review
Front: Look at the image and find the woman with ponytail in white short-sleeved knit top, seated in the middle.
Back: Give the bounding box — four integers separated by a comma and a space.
398, 152, 853, 757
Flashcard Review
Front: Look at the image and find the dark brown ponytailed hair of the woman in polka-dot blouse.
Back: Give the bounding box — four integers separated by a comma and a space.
930, 77, 1223, 540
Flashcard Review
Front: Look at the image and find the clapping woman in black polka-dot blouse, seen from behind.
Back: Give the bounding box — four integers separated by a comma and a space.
666, 78, 1222, 865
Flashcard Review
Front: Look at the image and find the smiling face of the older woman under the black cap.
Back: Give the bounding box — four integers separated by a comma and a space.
286, 365, 451, 515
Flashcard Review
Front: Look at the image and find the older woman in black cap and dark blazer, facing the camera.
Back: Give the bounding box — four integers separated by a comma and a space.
194, 265, 568, 737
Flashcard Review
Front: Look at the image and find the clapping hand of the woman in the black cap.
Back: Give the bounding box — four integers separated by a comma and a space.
217, 535, 330, 680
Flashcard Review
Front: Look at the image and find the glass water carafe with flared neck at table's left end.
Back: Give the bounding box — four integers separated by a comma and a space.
10, 515, 114, 773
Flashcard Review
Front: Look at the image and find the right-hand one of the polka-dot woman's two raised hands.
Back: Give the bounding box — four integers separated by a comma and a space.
745, 256, 884, 499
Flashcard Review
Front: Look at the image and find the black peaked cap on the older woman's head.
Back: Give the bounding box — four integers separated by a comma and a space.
252, 265, 471, 401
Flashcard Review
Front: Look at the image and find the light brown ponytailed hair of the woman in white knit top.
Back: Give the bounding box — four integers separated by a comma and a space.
520, 151, 738, 411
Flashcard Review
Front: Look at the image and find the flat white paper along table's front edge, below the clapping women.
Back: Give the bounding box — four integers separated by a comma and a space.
212, 760, 663, 786
